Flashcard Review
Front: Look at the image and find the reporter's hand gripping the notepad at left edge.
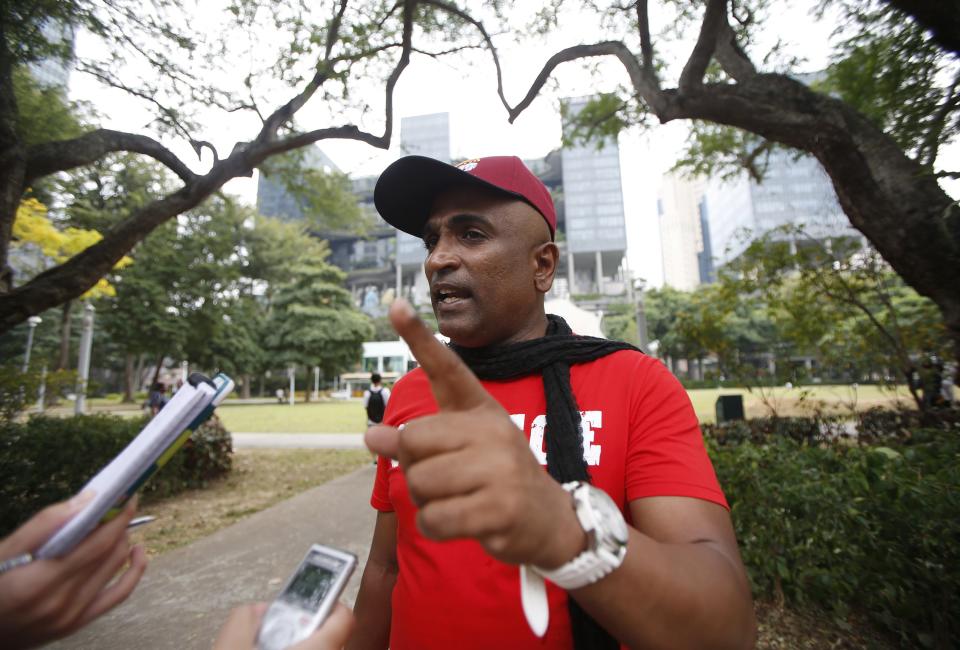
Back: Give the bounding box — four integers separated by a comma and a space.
0, 493, 147, 648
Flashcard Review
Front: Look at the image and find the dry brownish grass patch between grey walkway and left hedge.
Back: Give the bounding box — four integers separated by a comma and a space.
131, 449, 370, 556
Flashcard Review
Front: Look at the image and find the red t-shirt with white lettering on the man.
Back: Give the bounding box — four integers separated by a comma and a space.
370, 351, 727, 650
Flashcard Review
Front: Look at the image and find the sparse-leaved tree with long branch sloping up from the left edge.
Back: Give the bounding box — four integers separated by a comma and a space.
0, 0, 488, 332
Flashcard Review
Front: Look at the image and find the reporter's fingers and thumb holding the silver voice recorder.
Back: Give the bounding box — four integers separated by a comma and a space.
213, 603, 353, 650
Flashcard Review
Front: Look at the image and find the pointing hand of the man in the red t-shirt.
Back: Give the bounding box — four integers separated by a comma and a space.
365, 300, 586, 568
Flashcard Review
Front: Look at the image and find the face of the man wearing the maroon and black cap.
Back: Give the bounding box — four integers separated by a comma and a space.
423, 188, 557, 347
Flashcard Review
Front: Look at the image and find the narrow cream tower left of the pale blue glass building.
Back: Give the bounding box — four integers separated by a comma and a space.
657, 172, 709, 291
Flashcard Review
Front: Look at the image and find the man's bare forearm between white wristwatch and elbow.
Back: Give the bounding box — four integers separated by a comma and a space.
570, 528, 756, 650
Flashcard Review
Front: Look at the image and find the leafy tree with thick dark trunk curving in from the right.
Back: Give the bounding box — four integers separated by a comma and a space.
442, 0, 960, 359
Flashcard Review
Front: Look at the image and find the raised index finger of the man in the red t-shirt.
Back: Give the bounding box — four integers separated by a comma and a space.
390, 298, 493, 410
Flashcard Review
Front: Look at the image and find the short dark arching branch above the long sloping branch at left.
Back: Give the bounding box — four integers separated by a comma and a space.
26, 129, 197, 184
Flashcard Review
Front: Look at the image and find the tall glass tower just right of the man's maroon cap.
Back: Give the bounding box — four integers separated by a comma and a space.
561, 97, 627, 296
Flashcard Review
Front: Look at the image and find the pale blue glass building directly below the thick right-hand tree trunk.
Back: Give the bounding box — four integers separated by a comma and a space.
706, 144, 860, 266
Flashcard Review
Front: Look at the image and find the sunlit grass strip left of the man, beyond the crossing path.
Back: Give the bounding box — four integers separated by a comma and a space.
217, 401, 367, 433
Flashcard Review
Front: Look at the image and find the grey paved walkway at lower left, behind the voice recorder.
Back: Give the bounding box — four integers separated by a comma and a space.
48, 464, 375, 650
